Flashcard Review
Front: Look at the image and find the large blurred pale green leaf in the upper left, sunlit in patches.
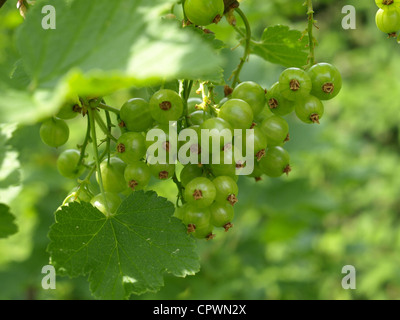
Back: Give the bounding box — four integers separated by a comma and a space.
0, 0, 222, 122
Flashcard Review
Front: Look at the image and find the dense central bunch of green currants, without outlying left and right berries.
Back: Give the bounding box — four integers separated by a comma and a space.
117, 83, 256, 239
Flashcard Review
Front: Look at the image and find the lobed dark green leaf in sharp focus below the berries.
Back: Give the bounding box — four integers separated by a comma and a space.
48, 192, 199, 299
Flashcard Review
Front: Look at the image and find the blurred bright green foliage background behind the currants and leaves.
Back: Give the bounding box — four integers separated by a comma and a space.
0, 0, 400, 299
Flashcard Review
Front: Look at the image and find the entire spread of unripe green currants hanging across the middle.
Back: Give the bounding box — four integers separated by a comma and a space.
40, 72, 341, 239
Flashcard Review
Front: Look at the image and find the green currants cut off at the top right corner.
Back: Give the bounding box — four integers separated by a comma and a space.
375, 0, 400, 37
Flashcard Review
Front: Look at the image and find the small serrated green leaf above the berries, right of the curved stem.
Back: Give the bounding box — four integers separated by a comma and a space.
252, 25, 308, 68
